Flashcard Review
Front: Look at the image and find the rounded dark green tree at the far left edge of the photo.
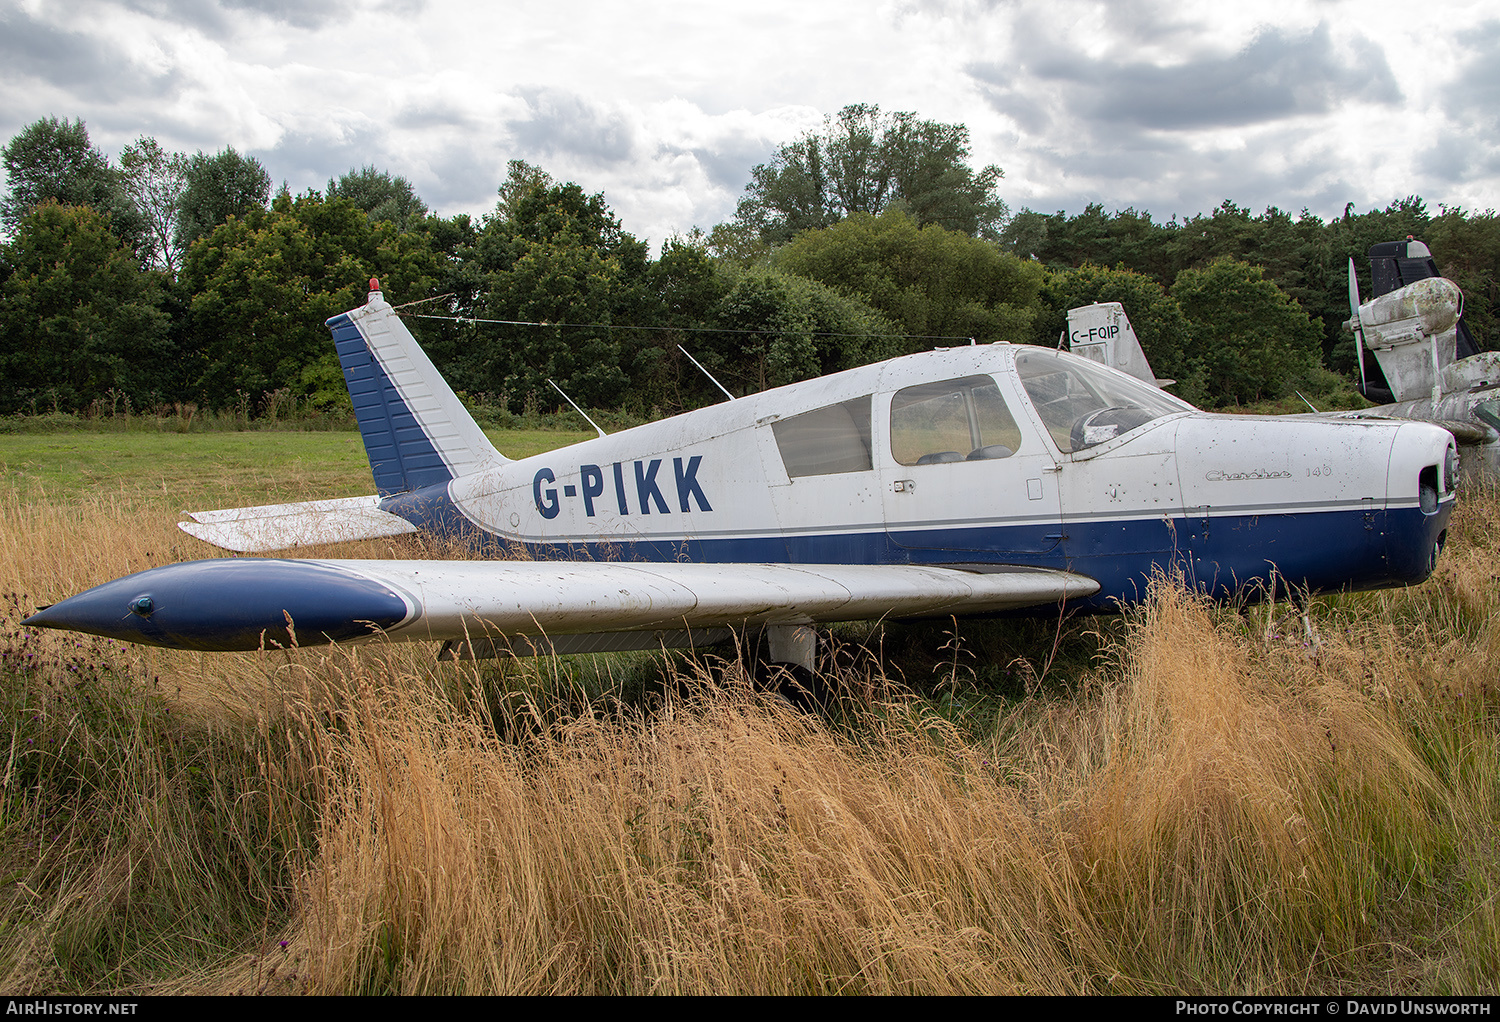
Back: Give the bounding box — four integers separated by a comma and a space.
0, 200, 180, 413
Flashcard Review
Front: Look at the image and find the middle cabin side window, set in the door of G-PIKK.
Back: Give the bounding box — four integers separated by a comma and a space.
891, 377, 1022, 465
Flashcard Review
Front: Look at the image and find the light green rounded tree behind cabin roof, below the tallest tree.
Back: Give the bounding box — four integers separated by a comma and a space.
776, 210, 1044, 351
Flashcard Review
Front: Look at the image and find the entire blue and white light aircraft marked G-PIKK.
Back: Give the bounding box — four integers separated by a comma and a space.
17, 281, 1457, 669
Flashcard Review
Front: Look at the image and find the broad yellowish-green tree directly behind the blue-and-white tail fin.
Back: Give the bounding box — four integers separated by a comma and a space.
182, 192, 438, 407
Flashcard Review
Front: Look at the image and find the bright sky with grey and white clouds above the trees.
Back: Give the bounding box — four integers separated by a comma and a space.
0, 0, 1500, 245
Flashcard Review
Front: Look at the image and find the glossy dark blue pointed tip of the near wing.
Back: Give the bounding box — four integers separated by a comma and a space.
21, 558, 411, 651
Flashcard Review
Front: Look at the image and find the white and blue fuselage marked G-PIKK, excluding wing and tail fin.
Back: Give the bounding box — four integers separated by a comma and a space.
381, 344, 1454, 609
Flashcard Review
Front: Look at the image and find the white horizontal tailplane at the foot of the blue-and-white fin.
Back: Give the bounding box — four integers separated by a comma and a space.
177, 495, 417, 554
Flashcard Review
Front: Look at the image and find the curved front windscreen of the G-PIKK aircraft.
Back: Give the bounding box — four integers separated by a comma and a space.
1016, 347, 1193, 453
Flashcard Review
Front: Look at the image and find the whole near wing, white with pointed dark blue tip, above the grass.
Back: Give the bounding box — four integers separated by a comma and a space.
24, 558, 1100, 650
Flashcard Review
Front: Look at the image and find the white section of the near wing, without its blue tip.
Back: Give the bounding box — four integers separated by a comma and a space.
317, 561, 1100, 639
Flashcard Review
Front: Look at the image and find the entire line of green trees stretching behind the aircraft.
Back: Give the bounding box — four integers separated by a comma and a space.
0, 105, 1500, 416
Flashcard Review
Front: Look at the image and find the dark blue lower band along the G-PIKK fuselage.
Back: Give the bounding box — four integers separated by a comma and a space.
381, 486, 1454, 609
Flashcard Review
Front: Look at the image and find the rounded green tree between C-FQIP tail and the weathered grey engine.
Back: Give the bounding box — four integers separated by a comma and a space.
1172, 258, 1320, 405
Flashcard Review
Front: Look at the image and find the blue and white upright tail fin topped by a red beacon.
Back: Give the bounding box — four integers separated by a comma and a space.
327, 281, 509, 497
